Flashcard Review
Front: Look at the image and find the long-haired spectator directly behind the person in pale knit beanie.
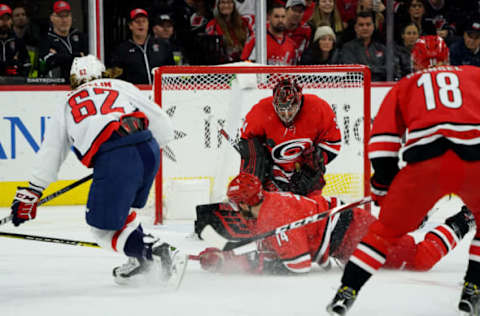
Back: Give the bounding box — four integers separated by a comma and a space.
311, 0, 348, 47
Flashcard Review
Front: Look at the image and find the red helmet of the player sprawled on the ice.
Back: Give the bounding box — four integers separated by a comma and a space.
227, 172, 263, 207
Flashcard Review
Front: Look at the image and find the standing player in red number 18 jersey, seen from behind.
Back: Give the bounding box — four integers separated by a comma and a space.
327, 36, 480, 315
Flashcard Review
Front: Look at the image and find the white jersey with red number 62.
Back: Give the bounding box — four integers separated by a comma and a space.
30, 79, 174, 188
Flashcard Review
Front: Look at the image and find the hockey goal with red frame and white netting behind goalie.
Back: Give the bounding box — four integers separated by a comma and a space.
151, 65, 370, 223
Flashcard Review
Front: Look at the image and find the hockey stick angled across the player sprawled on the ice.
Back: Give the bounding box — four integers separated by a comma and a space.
200, 196, 372, 254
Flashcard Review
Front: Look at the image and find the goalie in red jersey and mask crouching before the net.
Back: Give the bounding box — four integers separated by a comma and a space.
239, 79, 341, 205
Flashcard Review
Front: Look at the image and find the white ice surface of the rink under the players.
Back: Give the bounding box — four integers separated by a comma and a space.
0, 198, 473, 316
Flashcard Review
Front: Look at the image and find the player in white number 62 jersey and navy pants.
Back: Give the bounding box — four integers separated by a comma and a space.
11, 55, 187, 288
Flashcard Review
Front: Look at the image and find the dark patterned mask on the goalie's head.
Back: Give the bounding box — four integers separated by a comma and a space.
273, 79, 302, 126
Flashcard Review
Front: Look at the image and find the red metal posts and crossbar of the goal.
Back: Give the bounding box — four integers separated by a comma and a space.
152, 65, 371, 225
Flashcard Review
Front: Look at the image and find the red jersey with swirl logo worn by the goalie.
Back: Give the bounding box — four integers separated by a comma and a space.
241, 94, 341, 196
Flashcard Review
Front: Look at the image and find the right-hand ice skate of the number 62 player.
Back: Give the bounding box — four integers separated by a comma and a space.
152, 243, 188, 290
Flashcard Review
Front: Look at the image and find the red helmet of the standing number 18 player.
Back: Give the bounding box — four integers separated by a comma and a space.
412, 35, 449, 71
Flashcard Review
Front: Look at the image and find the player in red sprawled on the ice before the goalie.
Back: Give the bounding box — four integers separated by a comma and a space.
199, 173, 473, 274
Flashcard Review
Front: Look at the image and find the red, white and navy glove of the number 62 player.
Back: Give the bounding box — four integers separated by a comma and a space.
11, 187, 42, 226
